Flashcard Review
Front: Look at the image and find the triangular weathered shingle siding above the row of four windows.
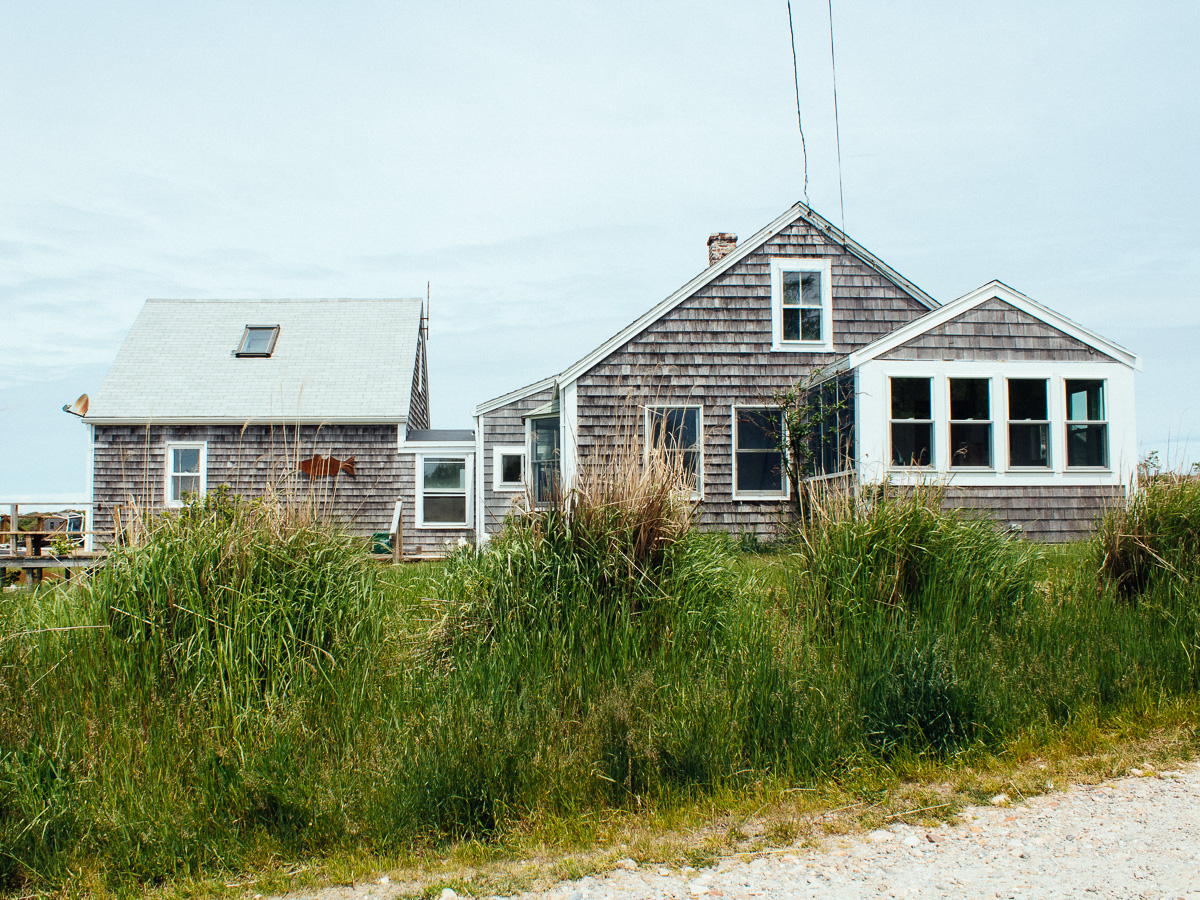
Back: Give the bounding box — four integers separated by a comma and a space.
880, 298, 1112, 362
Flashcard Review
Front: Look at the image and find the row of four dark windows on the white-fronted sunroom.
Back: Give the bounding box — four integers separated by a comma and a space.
890, 377, 1109, 469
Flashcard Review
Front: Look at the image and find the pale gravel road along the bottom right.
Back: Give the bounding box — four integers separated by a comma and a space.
285, 764, 1200, 900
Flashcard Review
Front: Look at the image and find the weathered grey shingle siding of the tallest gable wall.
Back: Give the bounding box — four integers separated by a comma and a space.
571, 221, 928, 532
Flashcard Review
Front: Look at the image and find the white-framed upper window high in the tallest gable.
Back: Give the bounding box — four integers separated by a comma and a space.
770, 259, 833, 353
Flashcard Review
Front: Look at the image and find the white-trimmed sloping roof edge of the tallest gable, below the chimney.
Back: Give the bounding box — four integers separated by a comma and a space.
475, 203, 938, 415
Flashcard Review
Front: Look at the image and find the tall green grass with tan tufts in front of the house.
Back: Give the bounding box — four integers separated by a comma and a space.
0, 472, 1200, 892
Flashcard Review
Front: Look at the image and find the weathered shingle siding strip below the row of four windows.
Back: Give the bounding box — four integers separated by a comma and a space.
942, 484, 1126, 544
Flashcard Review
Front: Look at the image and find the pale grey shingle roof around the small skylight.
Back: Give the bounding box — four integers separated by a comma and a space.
86, 300, 421, 424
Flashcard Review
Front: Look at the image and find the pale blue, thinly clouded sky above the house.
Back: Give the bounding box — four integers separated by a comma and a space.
0, 0, 1200, 499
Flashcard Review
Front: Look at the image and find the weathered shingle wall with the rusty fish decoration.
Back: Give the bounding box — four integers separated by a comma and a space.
92, 425, 413, 546
